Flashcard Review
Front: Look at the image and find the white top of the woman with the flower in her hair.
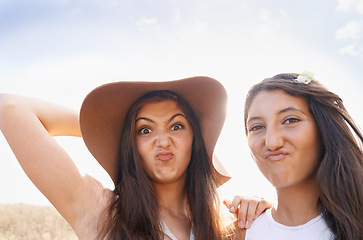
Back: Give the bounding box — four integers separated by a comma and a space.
245, 209, 334, 240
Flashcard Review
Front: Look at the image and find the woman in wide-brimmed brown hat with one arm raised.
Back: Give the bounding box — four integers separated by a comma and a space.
0, 77, 268, 240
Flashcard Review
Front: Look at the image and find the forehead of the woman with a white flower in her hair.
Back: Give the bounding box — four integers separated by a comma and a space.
248, 90, 309, 117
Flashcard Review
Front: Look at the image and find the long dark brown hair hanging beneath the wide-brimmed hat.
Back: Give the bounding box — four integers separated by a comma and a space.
100, 91, 222, 240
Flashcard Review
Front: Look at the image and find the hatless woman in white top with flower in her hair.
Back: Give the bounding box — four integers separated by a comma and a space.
229, 73, 363, 240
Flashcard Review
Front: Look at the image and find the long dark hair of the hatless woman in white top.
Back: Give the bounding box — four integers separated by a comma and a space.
244, 73, 363, 240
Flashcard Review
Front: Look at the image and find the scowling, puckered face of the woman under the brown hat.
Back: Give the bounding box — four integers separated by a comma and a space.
136, 100, 193, 186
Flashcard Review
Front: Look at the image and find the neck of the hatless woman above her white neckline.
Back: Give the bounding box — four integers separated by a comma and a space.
272, 179, 320, 226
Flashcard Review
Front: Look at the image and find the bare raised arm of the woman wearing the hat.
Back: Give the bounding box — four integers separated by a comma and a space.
0, 94, 102, 227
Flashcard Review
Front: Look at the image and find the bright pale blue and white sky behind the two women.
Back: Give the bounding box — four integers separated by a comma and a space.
0, 0, 363, 205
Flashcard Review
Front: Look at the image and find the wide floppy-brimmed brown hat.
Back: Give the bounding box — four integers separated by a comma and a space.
80, 77, 230, 186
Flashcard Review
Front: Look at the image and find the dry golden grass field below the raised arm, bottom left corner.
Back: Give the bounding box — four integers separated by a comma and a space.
0, 204, 77, 240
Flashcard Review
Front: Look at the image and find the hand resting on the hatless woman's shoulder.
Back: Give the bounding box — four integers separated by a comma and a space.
223, 195, 273, 229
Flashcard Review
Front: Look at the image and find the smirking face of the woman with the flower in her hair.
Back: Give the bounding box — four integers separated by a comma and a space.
247, 90, 320, 189
